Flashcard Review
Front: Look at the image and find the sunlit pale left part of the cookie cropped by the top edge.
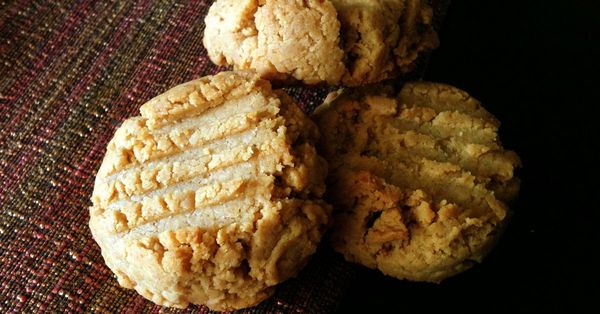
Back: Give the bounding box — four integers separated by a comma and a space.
203, 0, 344, 84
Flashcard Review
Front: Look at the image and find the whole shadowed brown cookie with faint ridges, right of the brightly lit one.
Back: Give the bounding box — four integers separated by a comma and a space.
315, 82, 520, 282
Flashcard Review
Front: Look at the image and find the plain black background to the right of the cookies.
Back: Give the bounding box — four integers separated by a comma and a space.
339, 1, 600, 313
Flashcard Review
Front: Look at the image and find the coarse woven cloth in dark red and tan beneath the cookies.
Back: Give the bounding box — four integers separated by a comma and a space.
0, 0, 446, 313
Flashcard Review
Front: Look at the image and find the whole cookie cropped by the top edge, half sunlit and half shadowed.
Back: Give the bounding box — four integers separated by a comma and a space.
203, 0, 438, 86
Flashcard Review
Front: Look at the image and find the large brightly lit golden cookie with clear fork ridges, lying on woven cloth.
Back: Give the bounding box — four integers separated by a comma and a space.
90, 72, 330, 310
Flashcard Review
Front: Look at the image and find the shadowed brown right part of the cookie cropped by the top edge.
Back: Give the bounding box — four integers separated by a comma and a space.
331, 0, 438, 86
